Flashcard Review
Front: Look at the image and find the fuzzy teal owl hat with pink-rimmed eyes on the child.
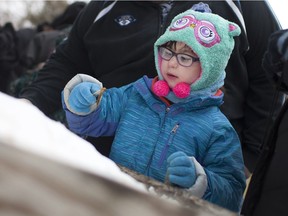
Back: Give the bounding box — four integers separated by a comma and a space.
154, 9, 241, 95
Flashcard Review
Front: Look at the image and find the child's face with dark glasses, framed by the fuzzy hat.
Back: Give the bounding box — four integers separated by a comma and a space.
159, 42, 201, 88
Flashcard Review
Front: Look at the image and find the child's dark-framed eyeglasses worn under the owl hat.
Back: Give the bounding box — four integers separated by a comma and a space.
158, 47, 199, 67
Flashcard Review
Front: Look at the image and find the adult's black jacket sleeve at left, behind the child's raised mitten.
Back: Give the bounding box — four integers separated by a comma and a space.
20, 1, 103, 115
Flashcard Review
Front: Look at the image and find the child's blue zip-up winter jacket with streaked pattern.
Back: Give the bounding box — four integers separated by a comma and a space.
63, 74, 245, 211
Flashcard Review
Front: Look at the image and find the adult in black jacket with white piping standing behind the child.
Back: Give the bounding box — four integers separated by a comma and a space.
20, 0, 281, 171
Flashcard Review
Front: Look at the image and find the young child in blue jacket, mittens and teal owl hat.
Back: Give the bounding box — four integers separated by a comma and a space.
62, 10, 245, 211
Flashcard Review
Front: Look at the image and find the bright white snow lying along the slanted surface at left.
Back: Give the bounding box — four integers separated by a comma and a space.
0, 92, 147, 193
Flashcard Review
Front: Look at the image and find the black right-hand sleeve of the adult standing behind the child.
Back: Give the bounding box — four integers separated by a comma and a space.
241, 1, 283, 170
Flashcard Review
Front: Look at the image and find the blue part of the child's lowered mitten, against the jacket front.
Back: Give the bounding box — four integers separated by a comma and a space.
167, 151, 196, 188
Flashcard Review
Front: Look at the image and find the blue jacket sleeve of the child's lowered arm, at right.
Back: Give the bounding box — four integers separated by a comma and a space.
201, 118, 246, 212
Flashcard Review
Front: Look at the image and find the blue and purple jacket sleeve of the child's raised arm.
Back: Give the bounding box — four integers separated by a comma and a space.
62, 80, 132, 137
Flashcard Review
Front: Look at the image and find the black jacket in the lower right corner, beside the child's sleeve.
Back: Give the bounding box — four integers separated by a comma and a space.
242, 98, 288, 216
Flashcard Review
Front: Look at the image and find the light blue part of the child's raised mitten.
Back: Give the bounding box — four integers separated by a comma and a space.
68, 82, 100, 113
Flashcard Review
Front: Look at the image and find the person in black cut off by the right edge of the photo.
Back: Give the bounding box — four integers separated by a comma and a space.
242, 29, 288, 216
